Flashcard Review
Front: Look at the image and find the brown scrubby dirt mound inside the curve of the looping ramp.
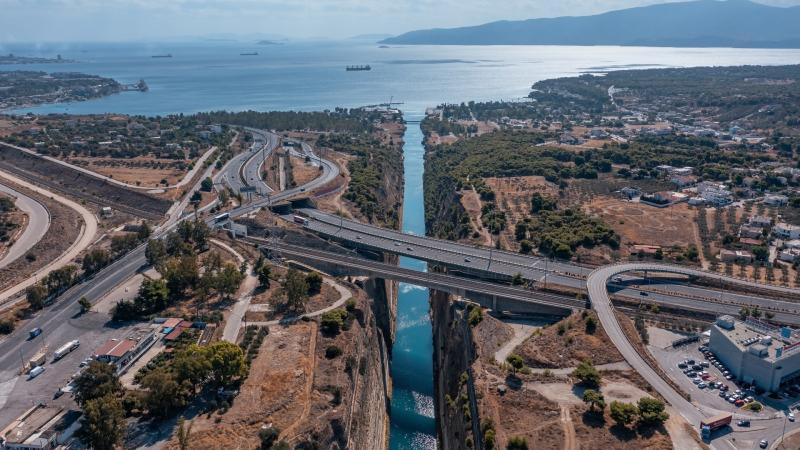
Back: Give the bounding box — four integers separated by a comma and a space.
512, 312, 623, 368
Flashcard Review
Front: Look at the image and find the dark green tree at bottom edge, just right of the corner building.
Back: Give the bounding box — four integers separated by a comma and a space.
80, 394, 125, 450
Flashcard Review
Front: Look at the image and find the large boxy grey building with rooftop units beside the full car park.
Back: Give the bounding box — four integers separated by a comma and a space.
709, 316, 800, 392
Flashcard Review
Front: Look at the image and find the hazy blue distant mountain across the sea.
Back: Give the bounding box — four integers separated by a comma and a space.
381, 0, 800, 48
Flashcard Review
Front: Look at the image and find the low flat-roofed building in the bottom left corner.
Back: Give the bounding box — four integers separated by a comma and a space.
0, 403, 81, 450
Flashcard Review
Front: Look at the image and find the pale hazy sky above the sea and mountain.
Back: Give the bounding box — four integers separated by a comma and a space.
0, 0, 800, 45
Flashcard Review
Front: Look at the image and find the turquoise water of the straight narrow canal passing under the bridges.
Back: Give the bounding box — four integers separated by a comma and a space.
389, 113, 436, 450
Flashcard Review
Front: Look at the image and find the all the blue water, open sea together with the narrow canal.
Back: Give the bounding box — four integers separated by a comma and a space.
0, 41, 800, 449
